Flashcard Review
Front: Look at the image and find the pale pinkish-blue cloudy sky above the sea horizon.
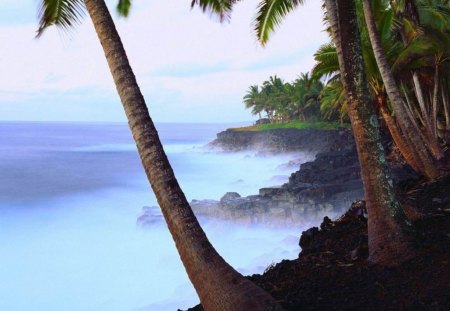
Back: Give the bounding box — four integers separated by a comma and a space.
0, 0, 328, 123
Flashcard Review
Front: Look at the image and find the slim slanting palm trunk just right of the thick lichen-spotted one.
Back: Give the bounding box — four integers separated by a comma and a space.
362, 0, 439, 179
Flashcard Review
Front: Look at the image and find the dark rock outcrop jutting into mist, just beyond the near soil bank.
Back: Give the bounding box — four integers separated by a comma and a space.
186, 146, 363, 226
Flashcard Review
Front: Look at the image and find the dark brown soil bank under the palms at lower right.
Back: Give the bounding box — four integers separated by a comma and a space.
184, 177, 450, 310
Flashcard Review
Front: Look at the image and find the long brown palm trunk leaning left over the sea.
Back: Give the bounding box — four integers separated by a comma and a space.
85, 0, 281, 311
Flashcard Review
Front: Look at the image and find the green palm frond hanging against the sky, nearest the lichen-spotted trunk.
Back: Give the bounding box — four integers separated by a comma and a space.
254, 0, 303, 45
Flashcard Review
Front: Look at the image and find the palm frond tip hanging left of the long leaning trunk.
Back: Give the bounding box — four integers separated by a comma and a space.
36, 0, 85, 37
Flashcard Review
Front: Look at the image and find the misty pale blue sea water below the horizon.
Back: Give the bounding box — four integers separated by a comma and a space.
0, 122, 314, 311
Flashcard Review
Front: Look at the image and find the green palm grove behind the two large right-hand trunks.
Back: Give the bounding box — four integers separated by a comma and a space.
243, 0, 450, 130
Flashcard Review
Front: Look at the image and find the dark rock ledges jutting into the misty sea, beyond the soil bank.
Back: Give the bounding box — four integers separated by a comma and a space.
138, 129, 370, 226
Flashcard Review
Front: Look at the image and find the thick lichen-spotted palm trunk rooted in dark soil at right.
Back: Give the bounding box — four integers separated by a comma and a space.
325, 0, 413, 266
